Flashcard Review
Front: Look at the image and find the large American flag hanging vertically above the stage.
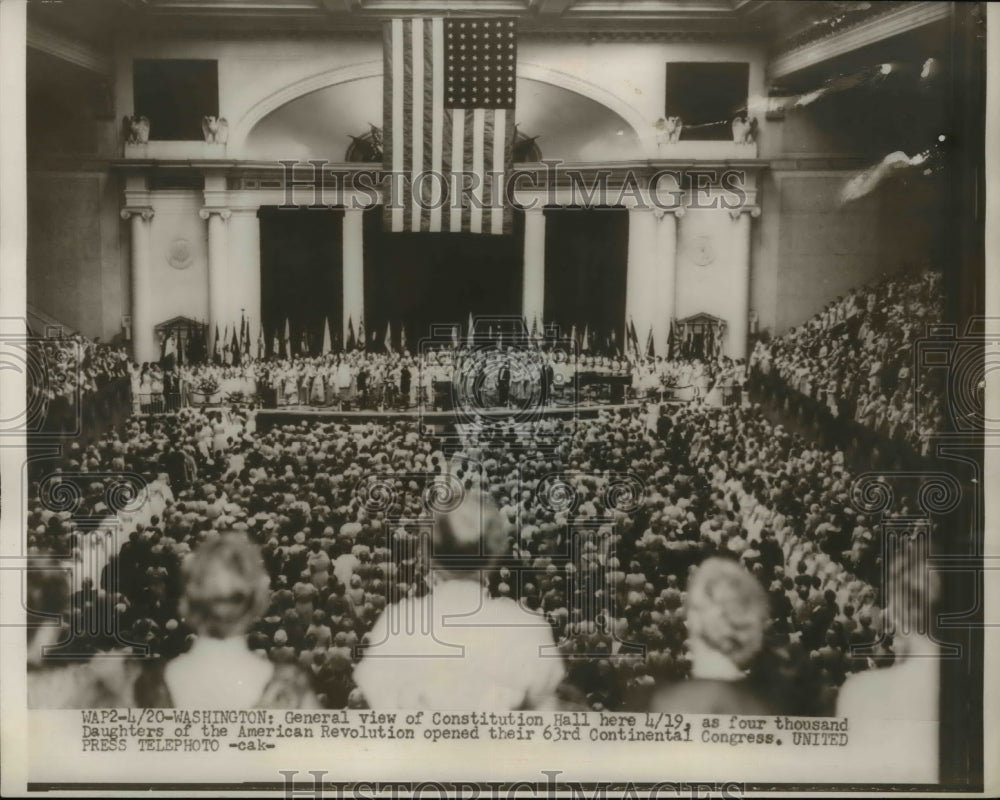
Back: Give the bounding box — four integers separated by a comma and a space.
383, 18, 517, 233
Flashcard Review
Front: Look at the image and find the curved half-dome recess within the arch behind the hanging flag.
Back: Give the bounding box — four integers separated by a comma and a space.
244, 77, 640, 161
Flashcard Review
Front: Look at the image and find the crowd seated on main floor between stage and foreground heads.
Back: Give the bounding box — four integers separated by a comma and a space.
27, 405, 928, 714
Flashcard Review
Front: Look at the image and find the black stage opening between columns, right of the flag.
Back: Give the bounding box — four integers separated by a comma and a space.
548, 208, 624, 350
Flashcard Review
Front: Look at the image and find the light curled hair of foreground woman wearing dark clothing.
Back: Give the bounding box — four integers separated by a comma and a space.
687, 558, 769, 669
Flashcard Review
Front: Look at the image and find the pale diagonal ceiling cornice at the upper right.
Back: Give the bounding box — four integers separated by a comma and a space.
767, 1, 951, 80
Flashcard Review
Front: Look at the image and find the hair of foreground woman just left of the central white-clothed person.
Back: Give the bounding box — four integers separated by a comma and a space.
181, 533, 271, 639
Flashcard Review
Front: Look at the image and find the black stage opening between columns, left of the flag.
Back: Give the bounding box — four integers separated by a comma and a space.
260, 208, 344, 355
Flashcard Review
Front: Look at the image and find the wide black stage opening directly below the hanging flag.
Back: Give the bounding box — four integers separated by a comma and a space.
366, 209, 524, 351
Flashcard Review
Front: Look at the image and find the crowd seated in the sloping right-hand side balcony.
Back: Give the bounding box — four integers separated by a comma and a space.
750, 272, 945, 455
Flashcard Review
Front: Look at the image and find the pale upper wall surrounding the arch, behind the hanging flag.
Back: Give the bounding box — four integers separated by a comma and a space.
115, 35, 770, 158
